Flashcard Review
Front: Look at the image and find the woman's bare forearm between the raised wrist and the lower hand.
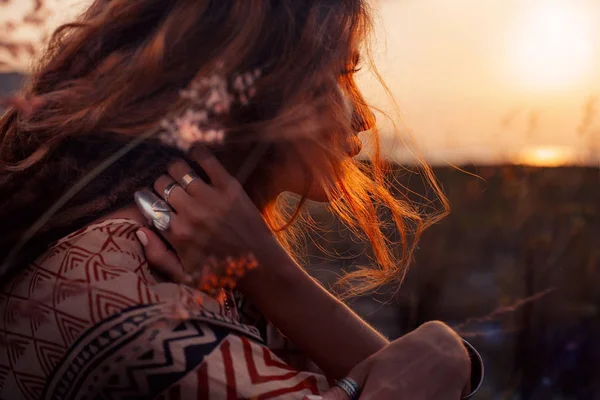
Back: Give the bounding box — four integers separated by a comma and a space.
240, 250, 388, 378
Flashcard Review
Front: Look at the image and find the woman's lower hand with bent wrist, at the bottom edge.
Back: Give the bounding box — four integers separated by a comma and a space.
308, 322, 471, 400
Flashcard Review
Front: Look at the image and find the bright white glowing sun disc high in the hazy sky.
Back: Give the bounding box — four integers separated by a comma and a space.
510, 0, 594, 89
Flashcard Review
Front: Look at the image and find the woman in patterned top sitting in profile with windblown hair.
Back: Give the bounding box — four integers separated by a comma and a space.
0, 0, 480, 399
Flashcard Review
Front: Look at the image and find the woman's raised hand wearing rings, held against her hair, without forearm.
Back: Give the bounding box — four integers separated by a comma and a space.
138, 149, 285, 283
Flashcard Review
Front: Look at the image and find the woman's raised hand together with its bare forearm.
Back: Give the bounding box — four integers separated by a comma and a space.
137, 152, 388, 378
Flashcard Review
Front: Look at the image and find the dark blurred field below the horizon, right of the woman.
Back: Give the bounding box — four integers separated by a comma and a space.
0, 74, 600, 400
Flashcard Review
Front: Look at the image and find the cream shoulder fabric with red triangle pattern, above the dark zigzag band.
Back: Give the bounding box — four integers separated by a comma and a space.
0, 220, 158, 399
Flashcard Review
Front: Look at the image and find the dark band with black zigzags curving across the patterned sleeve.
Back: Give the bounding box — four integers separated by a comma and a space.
44, 303, 260, 400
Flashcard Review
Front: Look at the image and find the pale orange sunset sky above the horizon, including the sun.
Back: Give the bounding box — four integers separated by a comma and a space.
0, 0, 600, 165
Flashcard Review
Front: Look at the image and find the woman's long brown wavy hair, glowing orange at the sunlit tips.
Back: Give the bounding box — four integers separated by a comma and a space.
0, 0, 445, 294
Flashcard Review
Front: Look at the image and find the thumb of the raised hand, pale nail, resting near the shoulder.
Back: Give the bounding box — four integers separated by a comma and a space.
135, 228, 191, 284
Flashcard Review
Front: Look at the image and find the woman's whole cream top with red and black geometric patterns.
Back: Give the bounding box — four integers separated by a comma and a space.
0, 220, 329, 400
